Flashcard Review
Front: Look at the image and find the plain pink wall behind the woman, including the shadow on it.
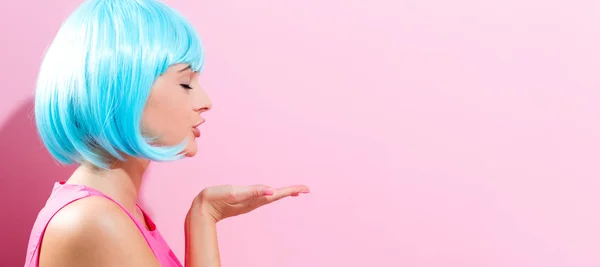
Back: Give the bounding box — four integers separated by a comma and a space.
0, 0, 600, 267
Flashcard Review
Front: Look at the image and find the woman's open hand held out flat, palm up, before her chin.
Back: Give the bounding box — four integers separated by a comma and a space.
190, 185, 310, 223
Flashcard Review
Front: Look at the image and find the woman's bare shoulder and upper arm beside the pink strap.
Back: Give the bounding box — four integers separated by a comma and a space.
40, 196, 159, 266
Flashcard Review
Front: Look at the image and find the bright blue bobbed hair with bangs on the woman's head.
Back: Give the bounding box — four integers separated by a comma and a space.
35, 0, 204, 169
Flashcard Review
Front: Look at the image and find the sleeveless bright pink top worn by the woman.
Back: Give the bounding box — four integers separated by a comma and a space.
25, 182, 182, 267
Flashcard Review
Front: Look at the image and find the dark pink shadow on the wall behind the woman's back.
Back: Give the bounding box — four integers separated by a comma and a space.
0, 99, 75, 266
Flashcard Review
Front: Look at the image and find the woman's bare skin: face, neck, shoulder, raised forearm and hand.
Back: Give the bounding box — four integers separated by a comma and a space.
39, 64, 309, 267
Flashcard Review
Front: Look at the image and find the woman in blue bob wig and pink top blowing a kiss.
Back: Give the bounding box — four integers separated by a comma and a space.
25, 0, 309, 267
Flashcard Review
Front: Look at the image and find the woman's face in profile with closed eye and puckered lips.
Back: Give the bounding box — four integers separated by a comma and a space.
142, 64, 212, 157
